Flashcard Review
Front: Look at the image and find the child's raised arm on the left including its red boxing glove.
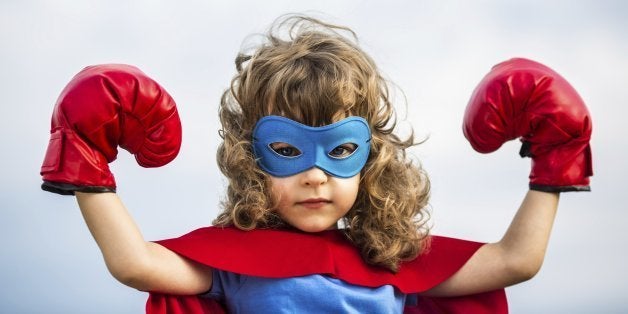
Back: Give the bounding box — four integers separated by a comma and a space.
41, 64, 211, 294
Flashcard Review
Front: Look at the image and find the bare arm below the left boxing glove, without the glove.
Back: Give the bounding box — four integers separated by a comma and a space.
76, 192, 212, 294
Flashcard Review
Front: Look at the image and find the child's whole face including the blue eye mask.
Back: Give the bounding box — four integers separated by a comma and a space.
253, 116, 371, 232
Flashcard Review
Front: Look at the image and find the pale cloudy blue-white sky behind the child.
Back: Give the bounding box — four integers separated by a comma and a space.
0, 0, 628, 313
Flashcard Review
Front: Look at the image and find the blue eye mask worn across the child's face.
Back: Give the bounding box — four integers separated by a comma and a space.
253, 116, 371, 178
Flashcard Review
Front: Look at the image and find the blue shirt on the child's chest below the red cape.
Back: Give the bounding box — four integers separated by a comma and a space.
207, 269, 405, 313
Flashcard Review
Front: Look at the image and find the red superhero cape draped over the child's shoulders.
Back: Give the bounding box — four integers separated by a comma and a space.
146, 227, 508, 314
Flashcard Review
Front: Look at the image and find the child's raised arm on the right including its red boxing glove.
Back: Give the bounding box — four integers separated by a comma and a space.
429, 59, 593, 295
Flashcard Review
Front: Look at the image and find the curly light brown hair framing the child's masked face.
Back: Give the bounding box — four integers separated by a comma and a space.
214, 16, 430, 272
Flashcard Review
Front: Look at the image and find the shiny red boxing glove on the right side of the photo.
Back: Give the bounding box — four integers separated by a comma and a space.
463, 59, 593, 192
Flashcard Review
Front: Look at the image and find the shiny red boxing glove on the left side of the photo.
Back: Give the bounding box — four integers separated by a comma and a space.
41, 64, 181, 195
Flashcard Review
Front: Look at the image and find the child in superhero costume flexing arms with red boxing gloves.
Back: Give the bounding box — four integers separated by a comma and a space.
42, 16, 592, 313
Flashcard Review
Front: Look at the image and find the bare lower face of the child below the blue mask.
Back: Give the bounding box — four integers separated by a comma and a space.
270, 168, 360, 232
